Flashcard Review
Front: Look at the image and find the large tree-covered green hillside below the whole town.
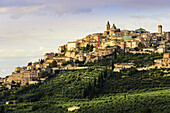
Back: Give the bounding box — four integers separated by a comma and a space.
0, 67, 170, 113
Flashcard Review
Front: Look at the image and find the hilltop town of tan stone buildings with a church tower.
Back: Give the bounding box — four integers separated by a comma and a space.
0, 22, 170, 90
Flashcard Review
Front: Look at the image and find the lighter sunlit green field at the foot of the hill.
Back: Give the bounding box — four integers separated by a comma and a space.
3, 88, 170, 113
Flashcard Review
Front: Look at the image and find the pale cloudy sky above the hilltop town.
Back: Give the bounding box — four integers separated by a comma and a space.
0, 0, 170, 77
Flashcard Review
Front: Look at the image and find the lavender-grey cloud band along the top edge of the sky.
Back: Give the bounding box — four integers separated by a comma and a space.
0, 0, 170, 17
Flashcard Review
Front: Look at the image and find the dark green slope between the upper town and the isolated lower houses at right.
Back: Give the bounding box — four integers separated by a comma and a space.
85, 52, 162, 67
